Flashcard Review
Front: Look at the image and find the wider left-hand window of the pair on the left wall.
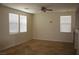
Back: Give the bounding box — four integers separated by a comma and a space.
9, 13, 18, 33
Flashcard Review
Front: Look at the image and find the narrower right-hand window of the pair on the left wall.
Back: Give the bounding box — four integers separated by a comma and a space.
20, 15, 27, 32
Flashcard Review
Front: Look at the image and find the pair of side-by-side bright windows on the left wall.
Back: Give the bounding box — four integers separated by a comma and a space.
9, 13, 27, 33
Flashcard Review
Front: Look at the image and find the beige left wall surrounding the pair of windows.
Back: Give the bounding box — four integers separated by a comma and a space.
0, 5, 32, 50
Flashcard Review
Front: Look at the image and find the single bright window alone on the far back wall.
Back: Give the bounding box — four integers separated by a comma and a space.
60, 16, 71, 32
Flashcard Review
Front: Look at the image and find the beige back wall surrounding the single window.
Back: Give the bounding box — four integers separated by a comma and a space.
33, 12, 75, 42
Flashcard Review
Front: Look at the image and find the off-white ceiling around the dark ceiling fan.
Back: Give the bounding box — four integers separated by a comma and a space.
3, 3, 79, 13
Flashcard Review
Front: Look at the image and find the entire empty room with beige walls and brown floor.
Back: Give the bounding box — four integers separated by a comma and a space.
0, 3, 79, 55
